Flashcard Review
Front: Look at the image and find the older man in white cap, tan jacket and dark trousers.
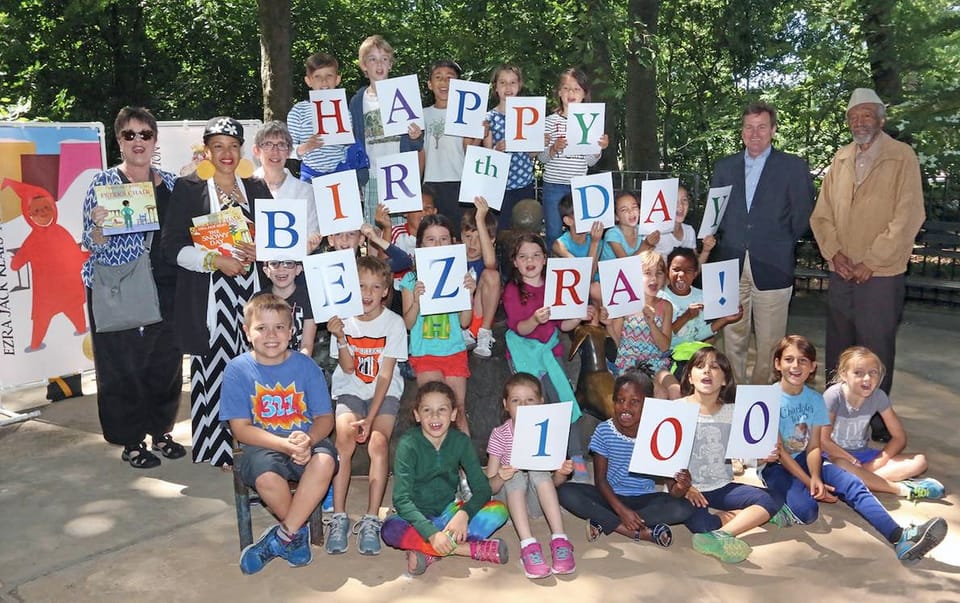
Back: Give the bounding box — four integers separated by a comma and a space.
810, 88, 926, 439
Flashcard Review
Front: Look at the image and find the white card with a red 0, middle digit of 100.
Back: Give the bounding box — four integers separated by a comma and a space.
630, 398, 700, 477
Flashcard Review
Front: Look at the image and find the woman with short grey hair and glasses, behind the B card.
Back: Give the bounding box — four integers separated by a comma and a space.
253, 121, 320, 253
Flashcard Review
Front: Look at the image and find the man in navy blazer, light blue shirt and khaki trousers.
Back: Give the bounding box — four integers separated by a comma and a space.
710, 102, 815, 384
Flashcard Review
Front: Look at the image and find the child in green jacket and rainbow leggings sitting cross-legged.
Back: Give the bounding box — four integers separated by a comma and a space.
381, 381, 507, 576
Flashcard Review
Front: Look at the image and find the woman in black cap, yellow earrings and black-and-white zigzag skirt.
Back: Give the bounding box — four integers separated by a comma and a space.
162, 117, 272, 467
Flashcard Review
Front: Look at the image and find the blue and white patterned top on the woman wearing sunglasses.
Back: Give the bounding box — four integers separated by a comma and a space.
80, 167, 177, 287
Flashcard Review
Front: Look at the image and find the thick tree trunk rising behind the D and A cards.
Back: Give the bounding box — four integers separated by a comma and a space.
623, 0, 660, 171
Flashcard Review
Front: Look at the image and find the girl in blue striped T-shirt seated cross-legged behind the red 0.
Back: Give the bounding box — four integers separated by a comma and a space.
557, 371, 694, 548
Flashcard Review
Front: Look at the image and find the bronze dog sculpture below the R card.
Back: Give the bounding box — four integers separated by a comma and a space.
567, 324, 614, 421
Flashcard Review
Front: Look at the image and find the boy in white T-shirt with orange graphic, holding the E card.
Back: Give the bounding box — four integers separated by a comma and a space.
326, 255, 407, 555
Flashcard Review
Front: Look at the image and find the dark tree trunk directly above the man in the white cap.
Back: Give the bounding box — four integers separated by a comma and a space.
860, 0, 903, 105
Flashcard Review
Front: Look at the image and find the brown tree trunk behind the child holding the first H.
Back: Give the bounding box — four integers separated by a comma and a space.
257, 0, 293, 122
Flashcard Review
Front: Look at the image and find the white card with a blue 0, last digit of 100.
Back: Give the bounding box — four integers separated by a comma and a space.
726, 384, 780, 459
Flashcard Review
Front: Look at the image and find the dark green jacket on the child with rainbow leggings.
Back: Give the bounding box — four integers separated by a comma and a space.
393, 425, 492, 540
